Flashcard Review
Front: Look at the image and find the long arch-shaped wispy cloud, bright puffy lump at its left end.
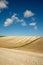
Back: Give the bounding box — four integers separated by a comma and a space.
4, 13, 26, 27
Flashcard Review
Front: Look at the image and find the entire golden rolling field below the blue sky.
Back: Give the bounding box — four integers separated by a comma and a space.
0, 36, 43, 65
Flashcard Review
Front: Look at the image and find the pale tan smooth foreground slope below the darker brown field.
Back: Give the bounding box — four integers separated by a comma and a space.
0, 48, 43, 65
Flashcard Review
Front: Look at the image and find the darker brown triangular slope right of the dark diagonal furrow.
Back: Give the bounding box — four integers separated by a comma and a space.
16, 37, 43, 53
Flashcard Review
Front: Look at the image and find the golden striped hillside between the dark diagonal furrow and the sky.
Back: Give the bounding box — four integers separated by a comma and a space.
0, 36, 40, 48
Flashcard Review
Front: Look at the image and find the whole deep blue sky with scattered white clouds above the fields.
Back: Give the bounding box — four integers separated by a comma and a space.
0, 0, 43, 36
